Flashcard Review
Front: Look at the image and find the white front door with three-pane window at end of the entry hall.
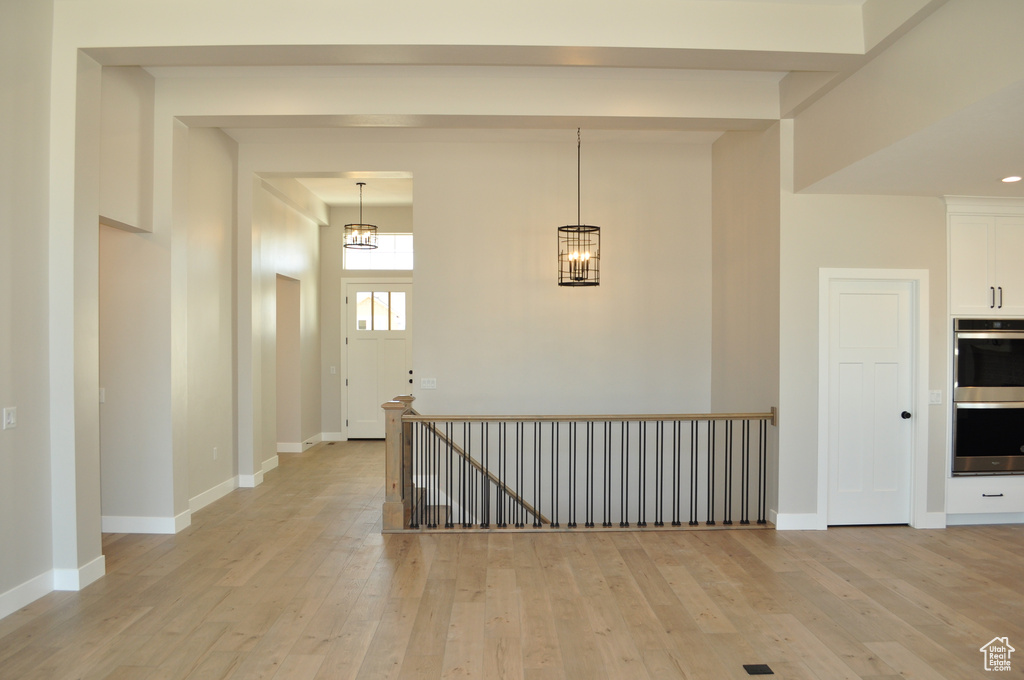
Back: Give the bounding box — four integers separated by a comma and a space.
345, 283, 413, 439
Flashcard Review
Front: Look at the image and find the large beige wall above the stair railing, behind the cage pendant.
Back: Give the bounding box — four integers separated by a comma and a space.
242, 133, 711, 414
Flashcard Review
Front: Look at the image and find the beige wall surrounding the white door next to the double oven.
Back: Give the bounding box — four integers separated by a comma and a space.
778, 134, 949, 514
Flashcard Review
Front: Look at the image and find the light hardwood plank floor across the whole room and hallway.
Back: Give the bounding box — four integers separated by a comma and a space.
0, 442, 1024, 680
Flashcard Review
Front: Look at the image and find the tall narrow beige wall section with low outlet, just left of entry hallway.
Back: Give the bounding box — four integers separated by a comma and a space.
186, 128, 238, 509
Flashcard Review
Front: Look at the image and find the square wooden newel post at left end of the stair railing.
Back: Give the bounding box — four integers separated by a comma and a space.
381, 394, 416, 532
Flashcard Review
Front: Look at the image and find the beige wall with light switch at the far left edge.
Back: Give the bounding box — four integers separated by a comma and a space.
0, 1, 53, 617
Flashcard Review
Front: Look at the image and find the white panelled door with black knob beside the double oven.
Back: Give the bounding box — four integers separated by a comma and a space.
827, 281, 914, 524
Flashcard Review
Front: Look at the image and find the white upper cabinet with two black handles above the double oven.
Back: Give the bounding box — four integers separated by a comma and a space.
949, 214, 1024, 316
